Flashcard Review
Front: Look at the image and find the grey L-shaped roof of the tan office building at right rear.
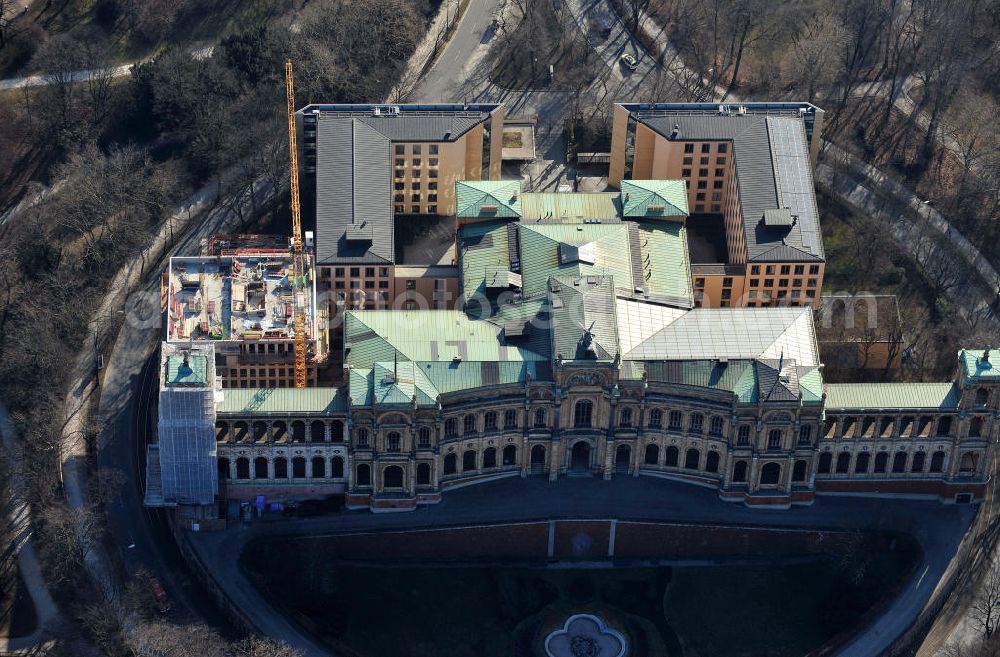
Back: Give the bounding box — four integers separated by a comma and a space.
624, 105, 825, 262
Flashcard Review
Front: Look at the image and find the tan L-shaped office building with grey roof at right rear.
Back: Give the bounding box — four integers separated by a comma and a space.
608, 103, 826, 308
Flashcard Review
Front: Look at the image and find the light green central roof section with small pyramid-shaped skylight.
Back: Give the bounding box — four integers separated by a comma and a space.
519, 224, 633, 296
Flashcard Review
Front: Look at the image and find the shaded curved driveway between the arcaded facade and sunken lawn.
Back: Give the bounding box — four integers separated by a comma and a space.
190, 477, 974, 657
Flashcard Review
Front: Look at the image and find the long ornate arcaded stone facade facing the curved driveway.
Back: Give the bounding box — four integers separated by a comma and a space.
218, 351, 1000, 510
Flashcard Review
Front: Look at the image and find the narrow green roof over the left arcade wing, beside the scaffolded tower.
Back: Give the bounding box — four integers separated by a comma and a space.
215, 388, 347, 415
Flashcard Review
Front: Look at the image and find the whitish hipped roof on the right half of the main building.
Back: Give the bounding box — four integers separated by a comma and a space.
623, 307, 819, 367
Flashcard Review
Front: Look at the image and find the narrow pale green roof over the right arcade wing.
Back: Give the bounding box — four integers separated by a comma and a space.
826, 383, 959, 410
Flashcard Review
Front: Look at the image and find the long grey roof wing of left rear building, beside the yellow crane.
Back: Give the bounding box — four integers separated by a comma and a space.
316, 114, 394, 264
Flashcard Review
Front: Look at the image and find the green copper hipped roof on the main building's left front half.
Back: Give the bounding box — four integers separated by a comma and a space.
344, 310, 545, 369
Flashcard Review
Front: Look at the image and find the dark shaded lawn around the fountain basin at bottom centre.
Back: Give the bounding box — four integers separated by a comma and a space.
241, 538, 916, 657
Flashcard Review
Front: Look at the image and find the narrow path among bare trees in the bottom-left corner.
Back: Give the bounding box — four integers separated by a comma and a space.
0, 402, 63, 655
